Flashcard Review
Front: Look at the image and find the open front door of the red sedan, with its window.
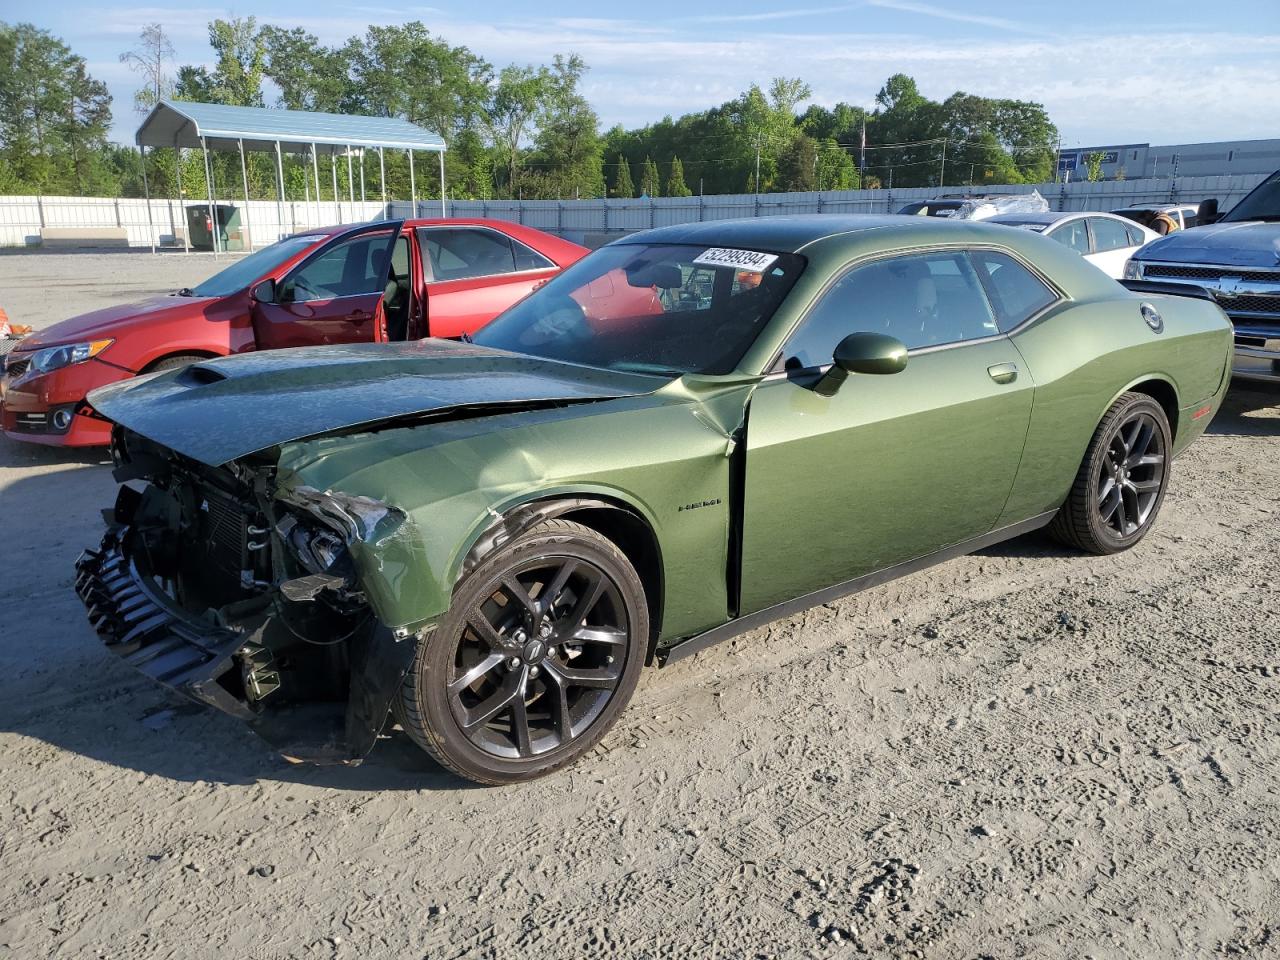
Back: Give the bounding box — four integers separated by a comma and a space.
253, 220, 404, 349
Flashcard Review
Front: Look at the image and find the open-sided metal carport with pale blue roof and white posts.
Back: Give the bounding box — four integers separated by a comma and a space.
134, 100, 445, 253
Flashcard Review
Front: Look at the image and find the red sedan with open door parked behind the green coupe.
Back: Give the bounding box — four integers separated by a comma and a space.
0, 220, 588, 447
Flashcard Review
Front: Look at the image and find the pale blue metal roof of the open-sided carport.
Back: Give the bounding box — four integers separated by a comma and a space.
136, 100, 445, 154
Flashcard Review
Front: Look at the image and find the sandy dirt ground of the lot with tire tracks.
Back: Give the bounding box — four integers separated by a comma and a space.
0, 256, 1280, 960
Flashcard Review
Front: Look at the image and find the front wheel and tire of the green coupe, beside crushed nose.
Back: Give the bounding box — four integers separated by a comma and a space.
394, 520, 649, 785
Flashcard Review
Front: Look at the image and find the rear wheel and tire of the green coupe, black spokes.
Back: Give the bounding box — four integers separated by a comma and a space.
1050, 393, 1172, 554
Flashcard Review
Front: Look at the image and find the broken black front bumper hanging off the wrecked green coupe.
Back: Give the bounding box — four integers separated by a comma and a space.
76, 525, 421, 763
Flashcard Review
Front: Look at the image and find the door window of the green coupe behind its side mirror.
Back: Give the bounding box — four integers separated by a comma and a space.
782, 251, 998, 370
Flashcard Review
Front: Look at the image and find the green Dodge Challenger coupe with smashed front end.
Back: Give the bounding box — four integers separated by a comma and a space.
77, 216, 1233, 783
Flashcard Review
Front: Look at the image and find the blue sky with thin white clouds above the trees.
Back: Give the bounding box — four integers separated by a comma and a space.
22, 0, 1280, 146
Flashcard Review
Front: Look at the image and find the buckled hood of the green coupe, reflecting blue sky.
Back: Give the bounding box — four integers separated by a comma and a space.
88, 339, 666, 466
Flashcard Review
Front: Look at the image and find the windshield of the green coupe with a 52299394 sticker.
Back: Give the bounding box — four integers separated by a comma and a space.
474, 243, 804, 376
